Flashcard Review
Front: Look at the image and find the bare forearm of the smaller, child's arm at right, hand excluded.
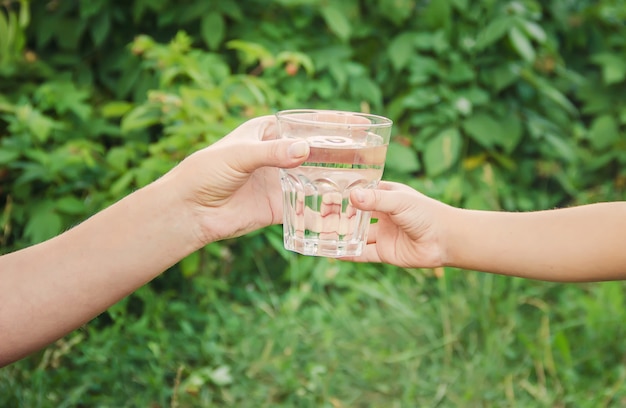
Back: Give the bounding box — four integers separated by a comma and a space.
447, 202, 626, 281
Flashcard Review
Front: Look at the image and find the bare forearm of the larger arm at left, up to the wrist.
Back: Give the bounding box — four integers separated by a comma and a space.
0, 177, 200, 366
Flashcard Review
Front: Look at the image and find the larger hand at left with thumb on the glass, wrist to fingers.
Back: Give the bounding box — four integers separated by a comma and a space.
163, 116, 309, 244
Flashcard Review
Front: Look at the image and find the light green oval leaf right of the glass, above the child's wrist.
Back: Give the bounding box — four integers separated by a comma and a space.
424, 128, 463, 177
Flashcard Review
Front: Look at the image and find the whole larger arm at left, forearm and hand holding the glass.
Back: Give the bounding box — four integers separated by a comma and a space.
0, 117, 308, 366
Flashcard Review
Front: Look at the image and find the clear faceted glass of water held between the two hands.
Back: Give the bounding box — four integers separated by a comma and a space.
276, 109, 392, 257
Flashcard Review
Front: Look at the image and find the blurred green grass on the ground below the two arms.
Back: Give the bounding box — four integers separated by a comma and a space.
0, 255, 626, 408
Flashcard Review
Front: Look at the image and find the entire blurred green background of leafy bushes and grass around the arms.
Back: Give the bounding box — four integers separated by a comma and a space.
0, 0, 626, 408
